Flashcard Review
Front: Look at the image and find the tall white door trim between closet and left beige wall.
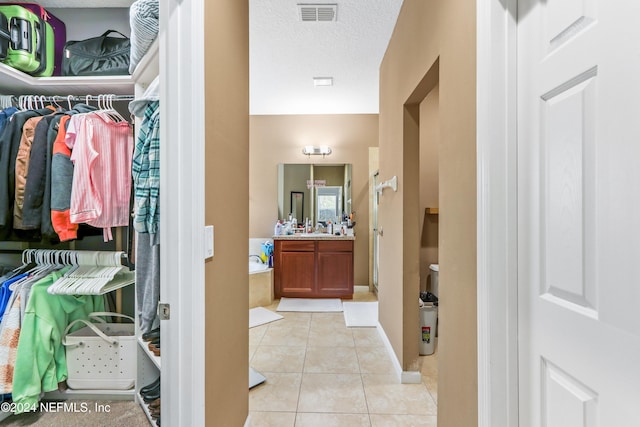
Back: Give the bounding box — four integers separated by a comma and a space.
160, 0, 205, 426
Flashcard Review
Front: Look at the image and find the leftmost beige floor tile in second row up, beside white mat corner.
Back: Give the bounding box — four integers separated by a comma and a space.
249, 372, 302, 412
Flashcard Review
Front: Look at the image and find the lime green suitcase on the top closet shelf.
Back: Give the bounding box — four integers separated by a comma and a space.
0, 5, 54, 77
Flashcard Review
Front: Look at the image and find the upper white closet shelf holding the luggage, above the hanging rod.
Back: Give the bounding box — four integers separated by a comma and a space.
0, 64, 134, 95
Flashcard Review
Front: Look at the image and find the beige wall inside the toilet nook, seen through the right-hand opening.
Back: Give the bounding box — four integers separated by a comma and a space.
420, 85, 440, 290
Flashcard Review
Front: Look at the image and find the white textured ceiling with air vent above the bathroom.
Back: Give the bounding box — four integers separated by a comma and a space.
249, 0, 402, 114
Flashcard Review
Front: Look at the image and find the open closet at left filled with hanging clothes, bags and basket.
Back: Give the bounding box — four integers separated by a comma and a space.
0, 0, 161, 425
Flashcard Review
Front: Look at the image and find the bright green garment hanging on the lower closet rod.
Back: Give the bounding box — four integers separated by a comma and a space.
13, 267, 105, 413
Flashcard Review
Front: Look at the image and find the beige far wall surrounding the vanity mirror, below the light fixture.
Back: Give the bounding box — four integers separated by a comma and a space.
249, 114, 378, 285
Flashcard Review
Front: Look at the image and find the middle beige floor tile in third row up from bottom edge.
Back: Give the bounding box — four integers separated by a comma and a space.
304, 347, 360, 374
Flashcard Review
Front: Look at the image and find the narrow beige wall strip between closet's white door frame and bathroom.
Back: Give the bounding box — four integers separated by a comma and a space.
204, 0, 249, 426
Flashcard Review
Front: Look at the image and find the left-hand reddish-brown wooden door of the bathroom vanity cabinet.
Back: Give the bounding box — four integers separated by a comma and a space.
275, 252, 315, 298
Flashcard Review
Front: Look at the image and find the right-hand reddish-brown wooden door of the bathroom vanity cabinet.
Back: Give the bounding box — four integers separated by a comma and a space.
316, 252, 353, 298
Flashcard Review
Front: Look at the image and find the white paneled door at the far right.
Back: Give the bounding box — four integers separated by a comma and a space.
517, 0, 640, 427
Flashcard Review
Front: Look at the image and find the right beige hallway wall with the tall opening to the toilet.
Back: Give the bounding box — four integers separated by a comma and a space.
379, 0, 477, 427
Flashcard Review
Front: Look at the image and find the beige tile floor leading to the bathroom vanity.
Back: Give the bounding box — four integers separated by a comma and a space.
249, 287, 438, 427
